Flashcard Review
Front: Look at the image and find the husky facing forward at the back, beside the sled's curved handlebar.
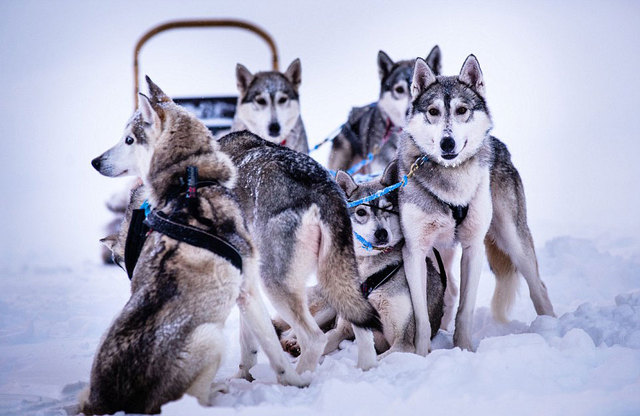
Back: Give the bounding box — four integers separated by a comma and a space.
231, 59, 309, 154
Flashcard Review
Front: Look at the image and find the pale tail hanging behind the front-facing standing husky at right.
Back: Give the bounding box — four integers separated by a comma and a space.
484, 236, 520, 323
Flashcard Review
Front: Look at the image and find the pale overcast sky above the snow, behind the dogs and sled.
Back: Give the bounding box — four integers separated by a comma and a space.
0, 0, 640, 267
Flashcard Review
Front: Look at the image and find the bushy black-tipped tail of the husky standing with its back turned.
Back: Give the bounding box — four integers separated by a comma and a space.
317, 207, 382, 330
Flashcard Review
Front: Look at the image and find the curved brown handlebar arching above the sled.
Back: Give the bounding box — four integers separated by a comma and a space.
133, 19, 278, 109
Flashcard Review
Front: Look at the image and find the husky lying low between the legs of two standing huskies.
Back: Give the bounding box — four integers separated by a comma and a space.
274, 161, 446, 355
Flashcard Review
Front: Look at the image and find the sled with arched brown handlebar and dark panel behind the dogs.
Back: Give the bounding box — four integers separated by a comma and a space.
133, 19, 278, 134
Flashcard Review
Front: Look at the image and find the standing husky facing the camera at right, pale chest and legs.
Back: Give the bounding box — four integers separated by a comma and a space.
398, 55, 554, 355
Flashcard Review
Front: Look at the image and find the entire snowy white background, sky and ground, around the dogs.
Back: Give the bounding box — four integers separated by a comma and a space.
0, 0, 640, 415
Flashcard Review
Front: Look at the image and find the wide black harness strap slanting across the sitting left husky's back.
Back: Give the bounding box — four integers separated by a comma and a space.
144, 210, 242, 272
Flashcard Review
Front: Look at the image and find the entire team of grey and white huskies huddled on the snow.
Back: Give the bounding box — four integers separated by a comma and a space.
78, 46, 554, 414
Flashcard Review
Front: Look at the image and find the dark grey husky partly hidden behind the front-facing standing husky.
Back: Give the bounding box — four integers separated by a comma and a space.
328, 45, 442, 173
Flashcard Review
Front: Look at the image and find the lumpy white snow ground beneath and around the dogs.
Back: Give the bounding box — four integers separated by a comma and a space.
0, 237, 640, 415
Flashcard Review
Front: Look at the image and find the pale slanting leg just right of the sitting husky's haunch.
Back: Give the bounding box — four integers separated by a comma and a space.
238, 262, 309, 387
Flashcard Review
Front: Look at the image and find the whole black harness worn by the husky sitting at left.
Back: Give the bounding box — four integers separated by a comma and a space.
124, 166, 242, 279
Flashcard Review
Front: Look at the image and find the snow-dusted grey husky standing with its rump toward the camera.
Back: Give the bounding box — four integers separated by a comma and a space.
218, 131, 380, 373
